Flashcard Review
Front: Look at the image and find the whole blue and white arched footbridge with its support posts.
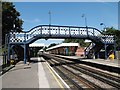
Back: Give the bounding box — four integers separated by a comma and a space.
8, 25, 115, 63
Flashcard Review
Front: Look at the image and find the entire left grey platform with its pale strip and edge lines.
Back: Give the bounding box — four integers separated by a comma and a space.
1, 57, 69, 90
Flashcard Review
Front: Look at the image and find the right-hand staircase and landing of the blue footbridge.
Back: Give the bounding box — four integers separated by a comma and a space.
85, 34, 115, 59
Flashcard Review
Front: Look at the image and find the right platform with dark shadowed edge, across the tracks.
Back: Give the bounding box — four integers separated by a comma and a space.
54, 55, 120, 74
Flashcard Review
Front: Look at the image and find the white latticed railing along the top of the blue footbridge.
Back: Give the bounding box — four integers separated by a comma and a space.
10, 25, 114, 43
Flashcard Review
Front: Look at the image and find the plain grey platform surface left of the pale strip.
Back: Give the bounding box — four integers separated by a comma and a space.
2, 62, 38, 88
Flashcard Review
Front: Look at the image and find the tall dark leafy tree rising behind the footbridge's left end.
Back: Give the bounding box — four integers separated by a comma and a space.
2, 2, 23, 45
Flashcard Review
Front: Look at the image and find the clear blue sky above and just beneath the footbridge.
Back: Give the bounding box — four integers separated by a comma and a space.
13, 2, 118, 45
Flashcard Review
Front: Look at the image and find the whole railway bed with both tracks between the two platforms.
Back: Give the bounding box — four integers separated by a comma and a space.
42, 55, 120, 90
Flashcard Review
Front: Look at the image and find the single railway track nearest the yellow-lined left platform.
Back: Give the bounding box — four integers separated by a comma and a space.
48, 59, 98, 90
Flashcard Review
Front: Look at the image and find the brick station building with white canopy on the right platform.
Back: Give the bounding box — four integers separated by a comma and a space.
46, 43, 84, 56
